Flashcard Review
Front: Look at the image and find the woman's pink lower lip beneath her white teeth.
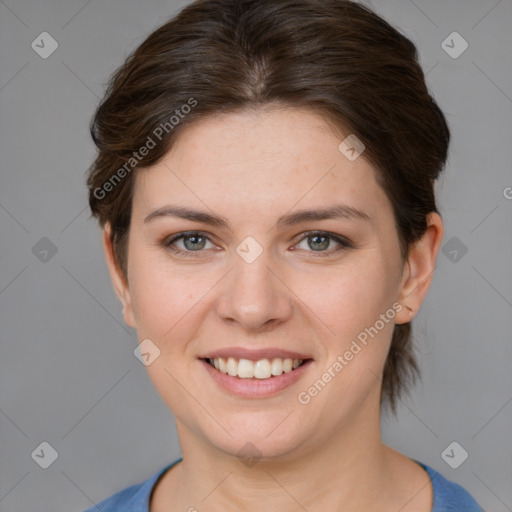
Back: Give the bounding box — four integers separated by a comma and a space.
200, 359, 313, 398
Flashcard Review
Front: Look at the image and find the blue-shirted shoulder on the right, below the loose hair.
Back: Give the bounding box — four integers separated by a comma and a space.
416, 461, 483, 512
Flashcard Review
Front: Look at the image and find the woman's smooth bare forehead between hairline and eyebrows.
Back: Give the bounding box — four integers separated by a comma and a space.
134, 109, 390, 227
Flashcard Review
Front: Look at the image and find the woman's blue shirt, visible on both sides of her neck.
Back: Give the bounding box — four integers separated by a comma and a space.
85, 459, 483, 512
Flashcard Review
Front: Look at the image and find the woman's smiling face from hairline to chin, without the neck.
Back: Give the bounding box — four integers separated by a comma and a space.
104, 110, 440, 457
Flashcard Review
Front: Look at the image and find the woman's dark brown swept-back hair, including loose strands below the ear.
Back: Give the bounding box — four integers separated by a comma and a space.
87, 0, 450, 412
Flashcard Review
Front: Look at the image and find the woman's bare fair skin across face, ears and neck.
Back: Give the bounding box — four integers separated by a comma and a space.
103, 108, 443, 512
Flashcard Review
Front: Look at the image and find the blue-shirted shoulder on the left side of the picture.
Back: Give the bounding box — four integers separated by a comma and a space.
85, 461, 177, 512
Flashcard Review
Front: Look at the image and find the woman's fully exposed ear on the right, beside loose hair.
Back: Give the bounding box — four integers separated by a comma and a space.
395, 212, 444, 324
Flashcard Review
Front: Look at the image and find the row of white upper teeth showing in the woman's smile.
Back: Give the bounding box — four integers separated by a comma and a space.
209, 357, 304, 379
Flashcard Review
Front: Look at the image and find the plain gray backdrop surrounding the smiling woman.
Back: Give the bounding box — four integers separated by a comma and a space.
0, 0, 512, 512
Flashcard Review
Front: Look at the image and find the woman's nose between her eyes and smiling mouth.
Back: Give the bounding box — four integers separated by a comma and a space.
217, 247, 293, 332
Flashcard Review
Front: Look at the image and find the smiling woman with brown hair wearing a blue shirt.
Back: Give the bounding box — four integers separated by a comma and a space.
84, 0, 481, 512
